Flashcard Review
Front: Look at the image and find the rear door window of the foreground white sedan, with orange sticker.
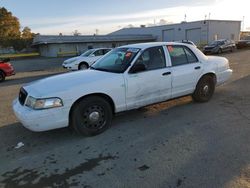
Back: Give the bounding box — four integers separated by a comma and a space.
167, 46, 188, 66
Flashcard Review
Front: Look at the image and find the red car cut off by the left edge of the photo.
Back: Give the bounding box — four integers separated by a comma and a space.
0, 58, 15, 82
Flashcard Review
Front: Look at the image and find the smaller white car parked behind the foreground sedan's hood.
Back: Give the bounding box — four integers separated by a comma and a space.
62, 48, 111, 70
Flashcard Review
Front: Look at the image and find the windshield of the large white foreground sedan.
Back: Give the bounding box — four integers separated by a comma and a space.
91, 48, 140, 73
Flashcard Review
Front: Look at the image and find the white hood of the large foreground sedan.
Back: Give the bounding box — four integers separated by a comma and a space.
24, 69, 119, 98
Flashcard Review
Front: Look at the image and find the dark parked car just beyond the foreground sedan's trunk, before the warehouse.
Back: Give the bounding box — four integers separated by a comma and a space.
203, 39, 236, 54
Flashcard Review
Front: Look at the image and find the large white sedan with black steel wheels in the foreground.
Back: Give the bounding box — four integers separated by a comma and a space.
13, 42, 232, 136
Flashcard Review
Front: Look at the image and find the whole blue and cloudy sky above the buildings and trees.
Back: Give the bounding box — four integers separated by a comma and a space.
0, 0, 250, 35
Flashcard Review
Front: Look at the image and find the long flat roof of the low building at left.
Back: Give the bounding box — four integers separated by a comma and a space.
33, 35, 156, 45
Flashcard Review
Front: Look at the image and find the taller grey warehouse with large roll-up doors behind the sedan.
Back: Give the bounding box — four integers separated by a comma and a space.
110, 20, 241, 46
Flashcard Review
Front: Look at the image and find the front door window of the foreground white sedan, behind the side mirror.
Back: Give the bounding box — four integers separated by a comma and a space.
135, 46, 166, 71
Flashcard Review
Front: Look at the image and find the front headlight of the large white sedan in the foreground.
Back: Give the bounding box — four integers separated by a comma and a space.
25, 96, 63, 110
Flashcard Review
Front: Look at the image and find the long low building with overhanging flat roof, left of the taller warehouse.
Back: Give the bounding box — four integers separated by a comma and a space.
33, 34, 156, 57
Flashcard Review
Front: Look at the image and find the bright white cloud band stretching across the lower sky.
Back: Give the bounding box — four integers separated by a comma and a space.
22, 0, 250, 34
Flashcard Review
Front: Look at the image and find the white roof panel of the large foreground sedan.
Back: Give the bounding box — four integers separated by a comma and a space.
119, 42, 191, 49
